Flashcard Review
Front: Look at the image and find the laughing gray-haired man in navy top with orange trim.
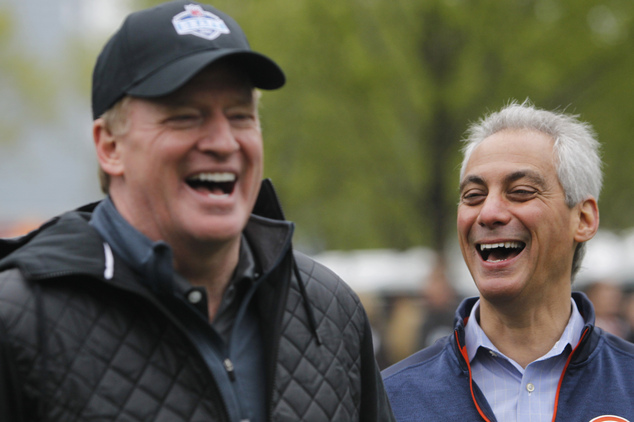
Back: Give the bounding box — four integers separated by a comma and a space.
383, 102, 634, 422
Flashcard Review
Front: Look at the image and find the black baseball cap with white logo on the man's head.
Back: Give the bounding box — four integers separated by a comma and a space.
92, 0, 286, 119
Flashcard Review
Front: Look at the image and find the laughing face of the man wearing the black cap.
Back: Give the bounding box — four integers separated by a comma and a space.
94, 64, 263, 254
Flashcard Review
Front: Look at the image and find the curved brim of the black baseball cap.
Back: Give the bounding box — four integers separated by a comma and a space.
126, 49, 286, 98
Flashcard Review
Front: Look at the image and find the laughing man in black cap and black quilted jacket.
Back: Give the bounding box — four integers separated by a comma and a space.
0, 0, 393, 422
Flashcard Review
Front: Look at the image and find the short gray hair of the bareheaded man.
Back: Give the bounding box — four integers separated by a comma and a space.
460, 100, 603, 279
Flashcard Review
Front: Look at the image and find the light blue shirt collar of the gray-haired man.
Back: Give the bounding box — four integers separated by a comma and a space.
465, 298, 584, 362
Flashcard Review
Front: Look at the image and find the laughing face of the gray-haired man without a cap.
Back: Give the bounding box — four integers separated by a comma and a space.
458, 130, 580, 303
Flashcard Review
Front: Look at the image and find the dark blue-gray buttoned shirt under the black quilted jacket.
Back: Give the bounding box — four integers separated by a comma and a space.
90, 197, 266, 422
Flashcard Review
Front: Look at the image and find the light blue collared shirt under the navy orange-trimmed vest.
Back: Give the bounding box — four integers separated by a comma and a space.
465, 299, 584, 422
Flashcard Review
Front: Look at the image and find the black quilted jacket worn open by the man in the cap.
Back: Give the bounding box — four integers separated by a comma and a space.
0, 183, 394, 422
